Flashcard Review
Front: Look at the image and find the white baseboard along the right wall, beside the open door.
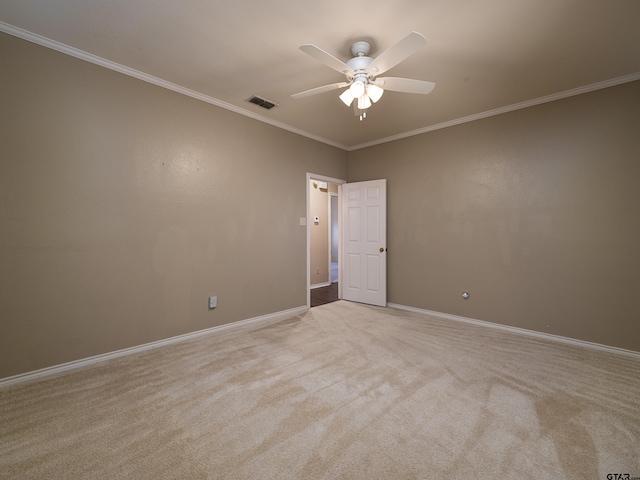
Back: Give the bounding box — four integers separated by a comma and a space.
387, 303, 640, 359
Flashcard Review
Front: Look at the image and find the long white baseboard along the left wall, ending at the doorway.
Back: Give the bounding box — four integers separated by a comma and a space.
0, 305, 309, 388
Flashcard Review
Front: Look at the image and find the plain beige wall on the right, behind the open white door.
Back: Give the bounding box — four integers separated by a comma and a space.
348, 82, 640, 351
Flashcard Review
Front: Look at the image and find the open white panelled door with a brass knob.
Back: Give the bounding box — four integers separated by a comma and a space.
341, 180, 387, 307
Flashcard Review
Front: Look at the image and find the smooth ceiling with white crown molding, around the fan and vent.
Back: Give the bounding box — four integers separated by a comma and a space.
0, 0, 640, 150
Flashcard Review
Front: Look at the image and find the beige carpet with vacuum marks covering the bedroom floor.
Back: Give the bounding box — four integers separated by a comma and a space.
0, 301, 640, 480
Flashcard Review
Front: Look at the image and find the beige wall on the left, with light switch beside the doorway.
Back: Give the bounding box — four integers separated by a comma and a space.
0, 34, 347, 378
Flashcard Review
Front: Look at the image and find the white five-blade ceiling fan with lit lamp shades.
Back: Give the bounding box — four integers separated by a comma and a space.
291, 32, 436, 121
